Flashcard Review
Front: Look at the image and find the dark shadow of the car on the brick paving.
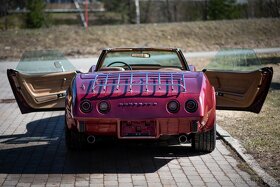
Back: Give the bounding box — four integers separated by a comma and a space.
0, 116, 209, 174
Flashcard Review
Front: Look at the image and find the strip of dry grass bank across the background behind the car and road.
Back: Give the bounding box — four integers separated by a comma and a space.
0, 19, 280, 59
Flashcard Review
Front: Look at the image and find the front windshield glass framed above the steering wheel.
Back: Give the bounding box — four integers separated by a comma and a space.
101, 51, 183, 69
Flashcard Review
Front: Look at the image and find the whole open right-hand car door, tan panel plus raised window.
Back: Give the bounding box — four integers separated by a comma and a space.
203, 49, 273, 113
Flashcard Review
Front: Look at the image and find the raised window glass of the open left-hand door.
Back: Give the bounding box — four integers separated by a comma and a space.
16, 50, 76, 74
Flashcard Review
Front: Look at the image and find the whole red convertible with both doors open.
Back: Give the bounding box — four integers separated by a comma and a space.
7, 48, 273, 152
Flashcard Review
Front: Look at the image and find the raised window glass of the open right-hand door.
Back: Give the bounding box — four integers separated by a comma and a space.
206, 49, 261, 71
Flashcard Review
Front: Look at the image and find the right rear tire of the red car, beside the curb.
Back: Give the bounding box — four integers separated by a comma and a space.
192, 124, 216, 153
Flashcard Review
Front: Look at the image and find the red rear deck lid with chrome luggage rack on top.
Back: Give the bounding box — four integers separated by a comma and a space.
78, 72, 201, 99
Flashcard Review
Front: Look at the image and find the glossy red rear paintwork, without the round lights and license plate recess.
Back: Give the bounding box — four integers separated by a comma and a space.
66, 71, 215, 139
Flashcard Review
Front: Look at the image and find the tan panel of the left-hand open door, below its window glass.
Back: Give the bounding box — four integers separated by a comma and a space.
7, 70, 76, 113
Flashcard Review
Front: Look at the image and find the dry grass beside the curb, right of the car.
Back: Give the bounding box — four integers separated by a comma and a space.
217, 64, 280, 181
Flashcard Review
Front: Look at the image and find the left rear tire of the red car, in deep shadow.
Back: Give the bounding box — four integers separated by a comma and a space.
64, 117, 86, 151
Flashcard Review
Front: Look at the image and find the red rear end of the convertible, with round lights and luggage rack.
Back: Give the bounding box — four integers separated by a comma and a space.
66, 71, 215, 142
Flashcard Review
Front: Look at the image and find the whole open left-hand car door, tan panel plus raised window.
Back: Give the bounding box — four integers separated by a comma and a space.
7, 50, 76, 114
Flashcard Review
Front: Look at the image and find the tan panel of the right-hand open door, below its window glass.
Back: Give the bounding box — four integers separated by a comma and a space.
205, 68, 273, 113
